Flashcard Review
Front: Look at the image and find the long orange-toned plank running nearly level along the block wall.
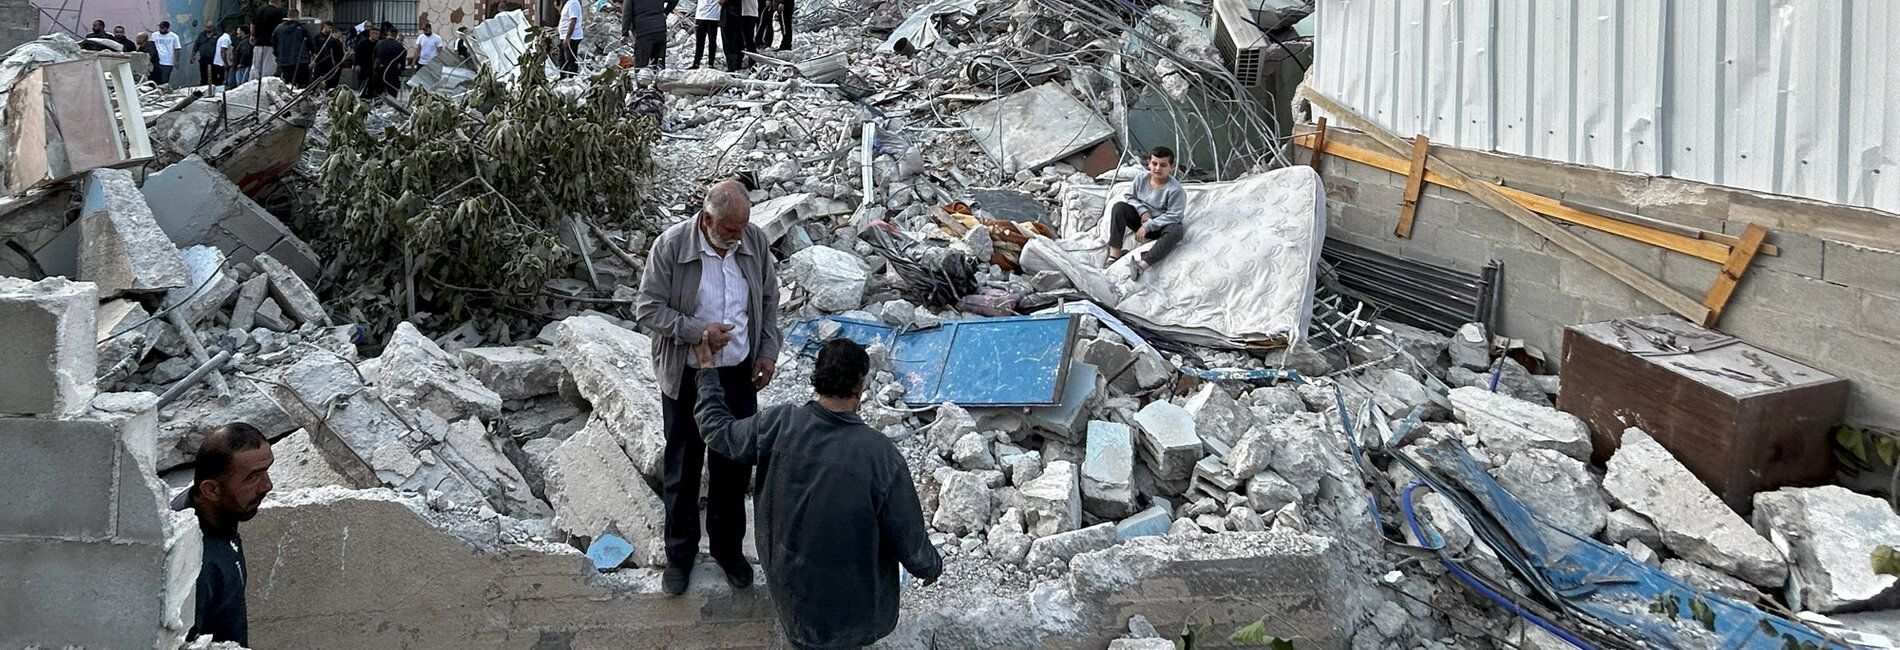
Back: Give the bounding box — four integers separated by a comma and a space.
1294, 135, 1780, 264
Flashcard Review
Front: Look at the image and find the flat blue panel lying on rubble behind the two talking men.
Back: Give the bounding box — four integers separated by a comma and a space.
785, 314, 1075, 407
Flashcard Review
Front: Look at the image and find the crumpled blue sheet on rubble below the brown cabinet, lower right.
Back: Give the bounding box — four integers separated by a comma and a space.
1419, 445, 1851, 650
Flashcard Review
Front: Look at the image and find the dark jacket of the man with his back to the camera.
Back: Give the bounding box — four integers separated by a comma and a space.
694, 371, 942, 648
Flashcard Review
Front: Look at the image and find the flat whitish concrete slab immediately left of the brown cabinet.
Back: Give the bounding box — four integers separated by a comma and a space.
1452, 386, 1590, 462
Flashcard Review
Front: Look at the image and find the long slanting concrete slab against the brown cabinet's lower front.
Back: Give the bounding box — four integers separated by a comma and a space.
1596, 429, 1788, 587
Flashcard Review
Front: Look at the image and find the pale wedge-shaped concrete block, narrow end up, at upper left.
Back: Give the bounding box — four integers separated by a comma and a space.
80, 169, 192, 298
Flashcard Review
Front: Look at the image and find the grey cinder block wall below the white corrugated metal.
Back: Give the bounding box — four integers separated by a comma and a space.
1296, 129, 1900, 430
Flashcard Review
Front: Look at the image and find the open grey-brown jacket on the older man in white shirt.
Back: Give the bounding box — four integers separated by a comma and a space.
633, 215, 783, 399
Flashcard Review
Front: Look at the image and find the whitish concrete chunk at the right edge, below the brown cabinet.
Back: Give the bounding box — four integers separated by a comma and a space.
1754, 485, 1900, 614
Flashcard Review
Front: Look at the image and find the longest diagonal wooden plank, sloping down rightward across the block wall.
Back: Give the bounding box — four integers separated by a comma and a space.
1300, 86, 1710, 323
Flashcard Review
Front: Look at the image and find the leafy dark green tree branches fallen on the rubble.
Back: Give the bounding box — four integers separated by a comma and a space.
304, 34, 659, 340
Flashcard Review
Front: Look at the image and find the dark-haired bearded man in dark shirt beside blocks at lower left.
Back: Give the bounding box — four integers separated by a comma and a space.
171, 422, 272, 646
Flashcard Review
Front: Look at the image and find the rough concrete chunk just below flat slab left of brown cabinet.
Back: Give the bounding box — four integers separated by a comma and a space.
1492, 449, 1609, 538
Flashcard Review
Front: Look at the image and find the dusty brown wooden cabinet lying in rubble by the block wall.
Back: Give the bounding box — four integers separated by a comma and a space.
1558, 315, 1847, 515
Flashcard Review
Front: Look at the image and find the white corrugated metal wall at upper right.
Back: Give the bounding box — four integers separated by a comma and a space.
1311, 0, 1900, 213
